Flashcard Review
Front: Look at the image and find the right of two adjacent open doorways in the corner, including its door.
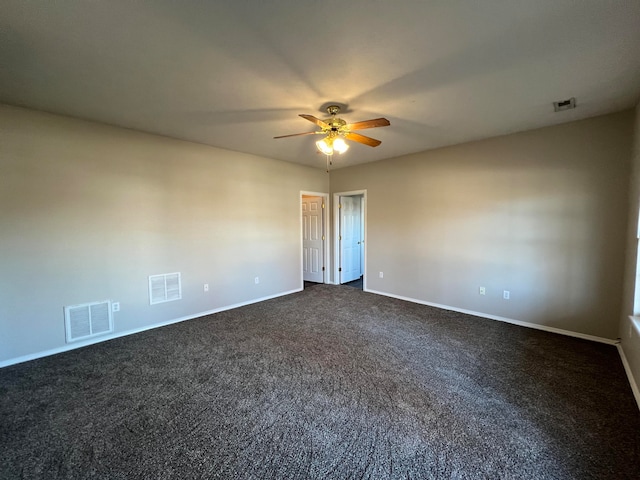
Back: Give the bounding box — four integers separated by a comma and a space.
334, 190, 367, 290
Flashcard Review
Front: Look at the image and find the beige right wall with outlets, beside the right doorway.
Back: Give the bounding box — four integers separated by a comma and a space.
331, 111, 633, 339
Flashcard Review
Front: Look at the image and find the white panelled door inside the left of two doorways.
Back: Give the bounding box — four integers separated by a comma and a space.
302, 197, 324, 283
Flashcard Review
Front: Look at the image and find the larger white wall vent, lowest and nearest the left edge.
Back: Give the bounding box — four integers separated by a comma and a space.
64, 300, 113, 343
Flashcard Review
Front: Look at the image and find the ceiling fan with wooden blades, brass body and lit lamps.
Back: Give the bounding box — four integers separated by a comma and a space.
273, 105, 391, 155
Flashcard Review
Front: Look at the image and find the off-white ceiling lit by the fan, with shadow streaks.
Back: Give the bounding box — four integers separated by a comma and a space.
0, 0, 640, 168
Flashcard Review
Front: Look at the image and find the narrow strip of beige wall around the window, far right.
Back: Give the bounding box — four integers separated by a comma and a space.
619, 104, 640, 398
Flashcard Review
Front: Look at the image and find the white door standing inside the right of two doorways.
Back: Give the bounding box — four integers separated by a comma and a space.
340, 196, 362, 283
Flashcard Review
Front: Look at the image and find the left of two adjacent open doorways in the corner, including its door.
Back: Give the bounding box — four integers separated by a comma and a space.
300, 192, 329, 288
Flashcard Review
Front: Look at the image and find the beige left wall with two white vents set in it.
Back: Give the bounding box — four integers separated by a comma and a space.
0, 105, 329, 363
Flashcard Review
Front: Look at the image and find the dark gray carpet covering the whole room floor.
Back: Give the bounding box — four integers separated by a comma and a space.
0, 285, 640, 480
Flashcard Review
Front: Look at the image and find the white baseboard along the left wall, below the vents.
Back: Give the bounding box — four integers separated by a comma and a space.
0, 288, 302, 368
